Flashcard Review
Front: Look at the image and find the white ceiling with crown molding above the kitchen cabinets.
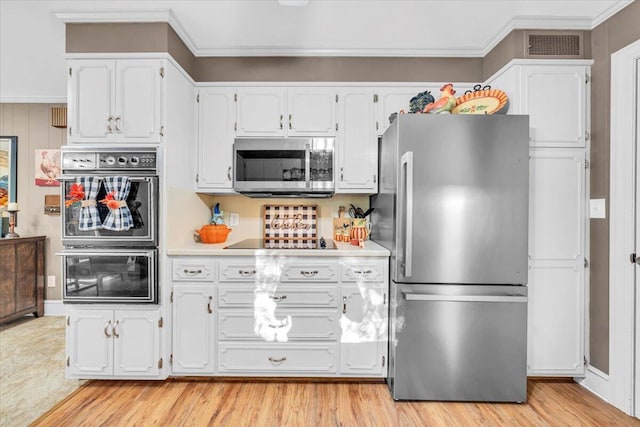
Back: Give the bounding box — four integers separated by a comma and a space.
48, 0, 630, 56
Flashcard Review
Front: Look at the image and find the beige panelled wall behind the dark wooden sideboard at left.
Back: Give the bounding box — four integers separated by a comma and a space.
0, 104, 67, 300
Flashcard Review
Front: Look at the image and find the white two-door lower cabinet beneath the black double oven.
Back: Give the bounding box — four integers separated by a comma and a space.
67, 309, 163, 378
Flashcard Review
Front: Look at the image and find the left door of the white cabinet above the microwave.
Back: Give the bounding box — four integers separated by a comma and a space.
236, 87, 286, 137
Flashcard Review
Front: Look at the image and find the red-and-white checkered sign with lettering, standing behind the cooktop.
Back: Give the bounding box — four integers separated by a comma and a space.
262, 205, 318, 243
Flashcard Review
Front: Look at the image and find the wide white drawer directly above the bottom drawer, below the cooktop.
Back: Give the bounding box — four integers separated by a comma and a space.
218, 309, 338, 342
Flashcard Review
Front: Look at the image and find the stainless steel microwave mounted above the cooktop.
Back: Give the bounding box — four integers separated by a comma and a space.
233, 138, 335, 197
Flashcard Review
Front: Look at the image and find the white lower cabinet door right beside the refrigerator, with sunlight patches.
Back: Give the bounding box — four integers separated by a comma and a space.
340, 284, 388, 377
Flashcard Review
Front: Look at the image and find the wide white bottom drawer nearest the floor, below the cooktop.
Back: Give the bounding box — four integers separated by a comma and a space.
218, 343, 337, 374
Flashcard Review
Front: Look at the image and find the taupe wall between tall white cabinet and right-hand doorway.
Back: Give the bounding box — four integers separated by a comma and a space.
589, 1, 640, 373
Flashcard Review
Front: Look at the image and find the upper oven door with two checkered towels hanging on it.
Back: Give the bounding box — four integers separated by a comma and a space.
61, 174, 158, 247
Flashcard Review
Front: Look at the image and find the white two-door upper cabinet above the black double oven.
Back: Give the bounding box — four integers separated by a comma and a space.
67, 59, 164, 143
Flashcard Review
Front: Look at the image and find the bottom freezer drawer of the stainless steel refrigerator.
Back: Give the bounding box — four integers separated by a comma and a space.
388, 283, 527, 402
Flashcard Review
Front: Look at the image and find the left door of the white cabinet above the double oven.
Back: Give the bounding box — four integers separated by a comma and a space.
67, 59, 116, 143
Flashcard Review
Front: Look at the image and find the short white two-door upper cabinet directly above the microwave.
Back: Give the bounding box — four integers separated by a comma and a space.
236, 87, 336, 137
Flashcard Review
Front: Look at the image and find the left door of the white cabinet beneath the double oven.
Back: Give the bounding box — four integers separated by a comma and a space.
67, 310, 113, 378
